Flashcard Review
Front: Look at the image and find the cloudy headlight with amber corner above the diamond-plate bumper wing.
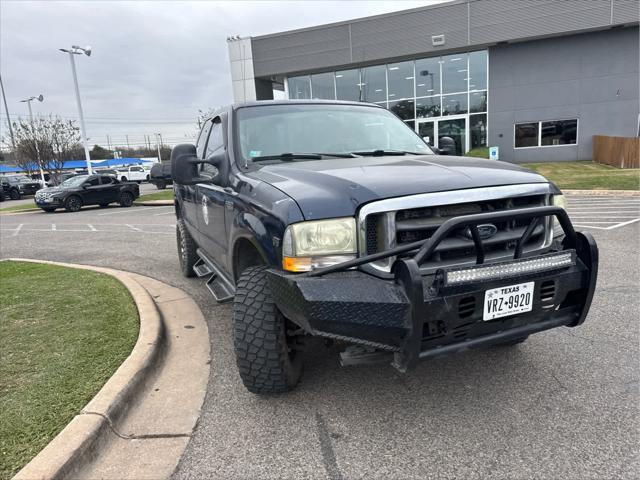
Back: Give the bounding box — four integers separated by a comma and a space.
282, 217, 357, 272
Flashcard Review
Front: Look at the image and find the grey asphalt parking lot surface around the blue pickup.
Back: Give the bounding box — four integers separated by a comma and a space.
0, 196, 640, 479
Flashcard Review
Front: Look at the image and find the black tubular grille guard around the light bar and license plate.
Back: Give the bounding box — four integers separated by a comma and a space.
302, 206, 598, 371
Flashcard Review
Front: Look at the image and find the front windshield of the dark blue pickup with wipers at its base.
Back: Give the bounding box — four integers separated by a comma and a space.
236, 104, 433, 164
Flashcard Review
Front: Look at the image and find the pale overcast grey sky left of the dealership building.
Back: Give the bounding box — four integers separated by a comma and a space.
0, 0, 442, 150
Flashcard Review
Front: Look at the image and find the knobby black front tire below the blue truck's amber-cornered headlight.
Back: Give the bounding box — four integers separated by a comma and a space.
233, 267, 302, 394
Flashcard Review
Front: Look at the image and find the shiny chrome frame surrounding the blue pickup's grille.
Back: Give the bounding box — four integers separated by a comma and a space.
357, 183, 553, 273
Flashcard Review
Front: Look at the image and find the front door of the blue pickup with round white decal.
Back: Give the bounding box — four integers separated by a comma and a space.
196, 117, 229, 272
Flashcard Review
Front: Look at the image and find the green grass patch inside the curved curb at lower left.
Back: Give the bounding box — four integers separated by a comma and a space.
0, 262, 139, 479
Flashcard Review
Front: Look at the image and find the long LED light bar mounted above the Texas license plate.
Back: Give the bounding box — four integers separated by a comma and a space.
444, 250, 576, 286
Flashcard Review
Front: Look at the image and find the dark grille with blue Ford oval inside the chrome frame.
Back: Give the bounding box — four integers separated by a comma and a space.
361, 189, 551, 271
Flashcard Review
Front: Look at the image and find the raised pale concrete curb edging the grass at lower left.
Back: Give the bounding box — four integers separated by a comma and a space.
7, 258, 164, 480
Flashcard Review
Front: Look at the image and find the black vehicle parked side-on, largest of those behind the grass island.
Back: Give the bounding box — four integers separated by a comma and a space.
35, 175, 140, 212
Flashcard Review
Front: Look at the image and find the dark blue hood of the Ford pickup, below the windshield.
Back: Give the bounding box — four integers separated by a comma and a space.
249, 155, 548, 220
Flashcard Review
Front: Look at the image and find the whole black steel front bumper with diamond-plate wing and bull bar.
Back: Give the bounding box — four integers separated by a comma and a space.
268, 206, 598, 371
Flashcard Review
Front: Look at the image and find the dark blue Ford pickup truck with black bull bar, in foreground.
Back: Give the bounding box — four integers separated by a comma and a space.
171, 101, 598, 393
